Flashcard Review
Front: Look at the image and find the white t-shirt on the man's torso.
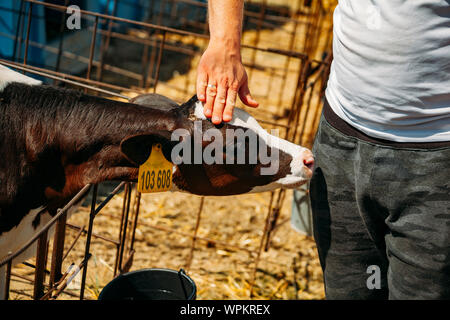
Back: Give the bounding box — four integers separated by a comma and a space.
326, 0, 450, 142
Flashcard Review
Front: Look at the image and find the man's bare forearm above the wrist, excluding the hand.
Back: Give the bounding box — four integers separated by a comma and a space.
208, 0, 244, 53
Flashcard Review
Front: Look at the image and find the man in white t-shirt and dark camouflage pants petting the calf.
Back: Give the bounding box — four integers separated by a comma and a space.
198, 0, 450, 299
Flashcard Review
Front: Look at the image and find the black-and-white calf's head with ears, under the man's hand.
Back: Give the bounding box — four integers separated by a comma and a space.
121, 94, 314, 195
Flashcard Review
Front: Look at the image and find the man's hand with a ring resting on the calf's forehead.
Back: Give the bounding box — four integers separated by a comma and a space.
197, 41, 258, 124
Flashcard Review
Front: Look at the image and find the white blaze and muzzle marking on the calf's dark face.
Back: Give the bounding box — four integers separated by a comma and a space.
195, 101, 314, 192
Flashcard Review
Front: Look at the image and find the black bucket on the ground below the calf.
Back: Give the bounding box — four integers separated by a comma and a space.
98, 269, 197, 300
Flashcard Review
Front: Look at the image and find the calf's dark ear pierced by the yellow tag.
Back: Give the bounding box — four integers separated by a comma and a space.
120, 131, 176, 166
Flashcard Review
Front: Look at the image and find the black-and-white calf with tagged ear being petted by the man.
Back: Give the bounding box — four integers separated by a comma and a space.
0, 66, 313, 298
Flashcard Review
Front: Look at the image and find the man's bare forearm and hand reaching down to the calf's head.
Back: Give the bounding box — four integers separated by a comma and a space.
197, 0, 258, 124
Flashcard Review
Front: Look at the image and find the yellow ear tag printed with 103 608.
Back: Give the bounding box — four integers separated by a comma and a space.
138, 143, 173, 193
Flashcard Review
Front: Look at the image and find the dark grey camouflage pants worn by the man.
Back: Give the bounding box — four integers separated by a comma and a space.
310, 111, 450, 299
